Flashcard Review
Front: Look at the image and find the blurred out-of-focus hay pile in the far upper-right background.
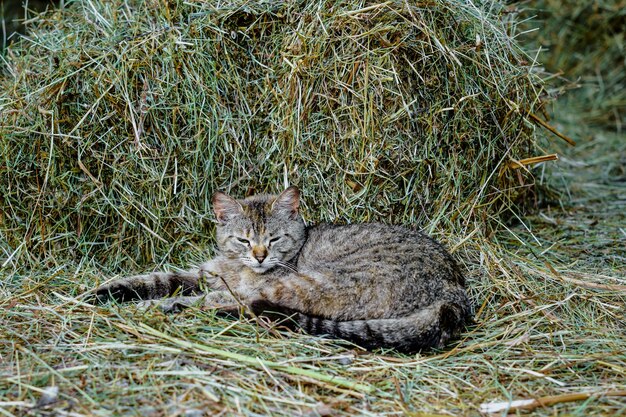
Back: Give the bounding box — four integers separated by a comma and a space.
525, 0, 626, 131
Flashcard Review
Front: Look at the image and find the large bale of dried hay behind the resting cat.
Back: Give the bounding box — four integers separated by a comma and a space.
0, 0, 542, 266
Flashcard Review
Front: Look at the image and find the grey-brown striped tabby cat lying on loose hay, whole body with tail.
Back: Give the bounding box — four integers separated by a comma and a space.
96, 186, 471, 353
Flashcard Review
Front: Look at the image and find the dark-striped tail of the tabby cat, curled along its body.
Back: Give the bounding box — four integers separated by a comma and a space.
252, 301, 472, 353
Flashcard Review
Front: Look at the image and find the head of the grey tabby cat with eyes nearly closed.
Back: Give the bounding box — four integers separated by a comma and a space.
213, 187, 306, 274
